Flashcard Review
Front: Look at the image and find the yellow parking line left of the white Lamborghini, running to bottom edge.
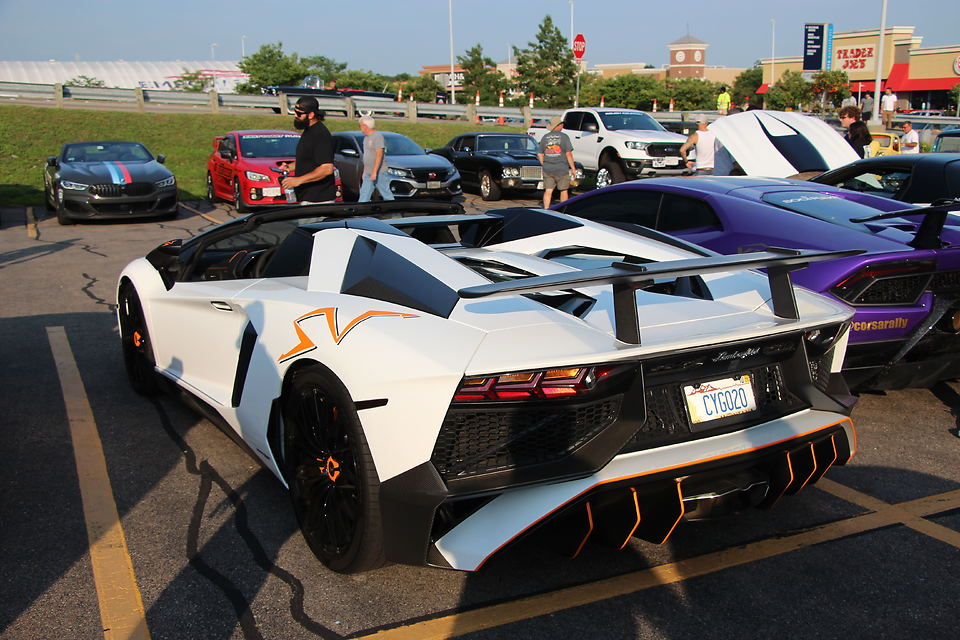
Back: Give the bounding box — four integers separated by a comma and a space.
47, 327, 150, 640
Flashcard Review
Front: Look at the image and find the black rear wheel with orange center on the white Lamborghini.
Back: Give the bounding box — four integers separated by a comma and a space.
283, 367, 384, 573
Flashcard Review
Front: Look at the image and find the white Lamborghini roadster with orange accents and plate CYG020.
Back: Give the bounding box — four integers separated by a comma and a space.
117, 200, 856, 572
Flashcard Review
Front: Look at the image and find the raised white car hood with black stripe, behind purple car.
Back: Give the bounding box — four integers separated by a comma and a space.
709, 110, 859, 178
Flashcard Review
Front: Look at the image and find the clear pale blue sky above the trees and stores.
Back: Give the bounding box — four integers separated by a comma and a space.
0, 0, 960, 75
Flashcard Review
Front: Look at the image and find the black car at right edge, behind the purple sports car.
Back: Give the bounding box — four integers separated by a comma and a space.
810, 153, 960, 204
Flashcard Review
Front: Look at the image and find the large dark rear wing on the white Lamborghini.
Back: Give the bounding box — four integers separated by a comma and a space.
457, 247, 864, 344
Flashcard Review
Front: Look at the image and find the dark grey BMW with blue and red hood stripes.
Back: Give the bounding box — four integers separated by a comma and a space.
43, 140, 178, 224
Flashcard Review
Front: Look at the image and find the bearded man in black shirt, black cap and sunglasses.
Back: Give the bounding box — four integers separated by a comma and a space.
283, 96, 337, 204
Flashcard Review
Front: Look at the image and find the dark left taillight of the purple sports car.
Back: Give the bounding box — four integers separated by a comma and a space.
830, 261, 934, 305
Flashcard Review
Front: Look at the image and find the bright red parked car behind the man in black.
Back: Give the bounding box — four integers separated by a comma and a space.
207, 130, 341, 213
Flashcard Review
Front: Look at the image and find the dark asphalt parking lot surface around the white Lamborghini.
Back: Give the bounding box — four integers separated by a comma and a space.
0, 196, 960, 640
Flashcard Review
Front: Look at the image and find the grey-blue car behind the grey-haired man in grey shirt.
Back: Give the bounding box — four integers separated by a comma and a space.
333, 131, 463, 200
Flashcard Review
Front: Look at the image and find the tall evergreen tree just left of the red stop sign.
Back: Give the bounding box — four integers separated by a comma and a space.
513, 16, 577, 107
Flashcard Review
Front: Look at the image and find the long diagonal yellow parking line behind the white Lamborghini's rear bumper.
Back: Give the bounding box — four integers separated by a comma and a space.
354, 479, 960, 640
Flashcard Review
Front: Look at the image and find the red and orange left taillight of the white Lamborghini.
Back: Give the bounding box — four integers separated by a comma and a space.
453, 365, 618, 402
